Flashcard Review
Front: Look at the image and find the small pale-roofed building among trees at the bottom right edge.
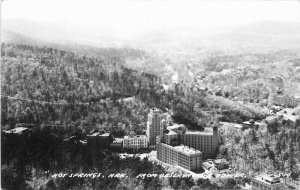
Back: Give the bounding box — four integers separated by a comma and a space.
252, 174, 284, 190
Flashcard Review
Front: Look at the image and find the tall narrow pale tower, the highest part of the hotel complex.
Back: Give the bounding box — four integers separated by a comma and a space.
146, 109, 161, 147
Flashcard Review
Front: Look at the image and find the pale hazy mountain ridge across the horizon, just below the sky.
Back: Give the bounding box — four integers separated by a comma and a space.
2, 19, 300, 53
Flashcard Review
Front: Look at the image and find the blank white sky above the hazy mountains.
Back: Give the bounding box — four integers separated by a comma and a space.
2, 0, 300, 49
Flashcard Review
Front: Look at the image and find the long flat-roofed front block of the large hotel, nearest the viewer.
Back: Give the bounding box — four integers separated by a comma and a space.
157, 143, 202, 170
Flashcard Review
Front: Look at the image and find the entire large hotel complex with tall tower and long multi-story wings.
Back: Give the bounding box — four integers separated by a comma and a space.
150, 110, 219, 170
